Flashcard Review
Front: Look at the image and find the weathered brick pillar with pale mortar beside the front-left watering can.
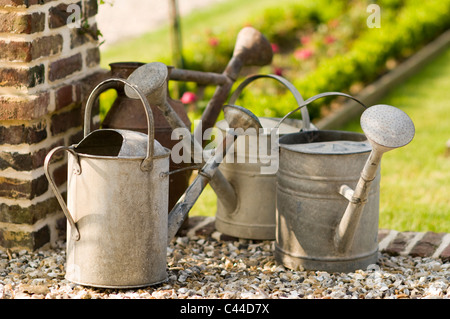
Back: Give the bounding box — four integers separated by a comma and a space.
0, 0, 104, 250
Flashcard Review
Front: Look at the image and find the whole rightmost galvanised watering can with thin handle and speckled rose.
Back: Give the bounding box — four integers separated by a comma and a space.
274, 92, 415, 272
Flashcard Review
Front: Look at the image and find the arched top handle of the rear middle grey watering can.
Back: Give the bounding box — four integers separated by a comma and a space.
228, 74, 311, 131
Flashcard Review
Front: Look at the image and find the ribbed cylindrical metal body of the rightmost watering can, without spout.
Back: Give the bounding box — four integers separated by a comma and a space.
274, 131, 380, 272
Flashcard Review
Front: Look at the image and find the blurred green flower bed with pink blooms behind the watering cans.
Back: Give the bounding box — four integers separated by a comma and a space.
178, 0, 450, 119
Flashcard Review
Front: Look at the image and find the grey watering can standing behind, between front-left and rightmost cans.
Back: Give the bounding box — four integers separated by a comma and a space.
215, 74, 316, 240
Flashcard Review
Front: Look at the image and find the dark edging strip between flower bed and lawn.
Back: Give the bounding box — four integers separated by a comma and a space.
315, 30, 450, 130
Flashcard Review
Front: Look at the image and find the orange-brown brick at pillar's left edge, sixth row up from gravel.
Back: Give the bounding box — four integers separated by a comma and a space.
0, 92, 50, 121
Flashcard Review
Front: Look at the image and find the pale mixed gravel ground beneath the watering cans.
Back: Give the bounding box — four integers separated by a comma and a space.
0, 236, 450, 299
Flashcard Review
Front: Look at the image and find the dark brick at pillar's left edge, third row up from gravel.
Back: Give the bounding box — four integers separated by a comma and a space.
0, 175, 48, 199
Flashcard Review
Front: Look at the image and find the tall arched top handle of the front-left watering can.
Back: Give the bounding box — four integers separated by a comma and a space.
84, 78, 155, 171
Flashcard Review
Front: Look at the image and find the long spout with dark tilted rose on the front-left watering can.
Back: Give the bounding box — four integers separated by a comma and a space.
167, 105, 262, 243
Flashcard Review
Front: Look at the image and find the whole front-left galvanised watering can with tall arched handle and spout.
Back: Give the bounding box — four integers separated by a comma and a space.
44, 78, 260, 288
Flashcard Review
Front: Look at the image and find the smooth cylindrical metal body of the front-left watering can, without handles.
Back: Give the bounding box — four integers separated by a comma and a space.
66, 136, 169, 288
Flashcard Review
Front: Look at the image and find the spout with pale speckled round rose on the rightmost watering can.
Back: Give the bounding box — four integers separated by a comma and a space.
334, 105, 415, 253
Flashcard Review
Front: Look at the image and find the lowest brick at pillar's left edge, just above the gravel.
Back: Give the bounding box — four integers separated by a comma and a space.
0, 225, 50, 250
